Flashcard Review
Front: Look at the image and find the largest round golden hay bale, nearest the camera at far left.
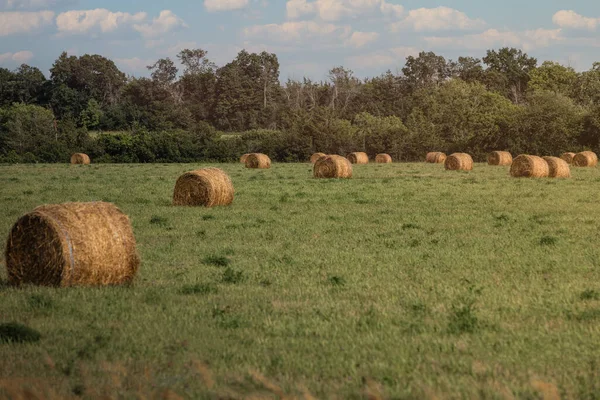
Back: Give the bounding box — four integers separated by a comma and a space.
5, 202, 140, 287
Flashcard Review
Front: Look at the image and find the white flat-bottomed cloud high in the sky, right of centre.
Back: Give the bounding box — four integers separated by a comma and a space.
390, 7, 485, 32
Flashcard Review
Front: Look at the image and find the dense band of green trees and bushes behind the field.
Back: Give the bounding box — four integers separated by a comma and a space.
0, 48, 600, 163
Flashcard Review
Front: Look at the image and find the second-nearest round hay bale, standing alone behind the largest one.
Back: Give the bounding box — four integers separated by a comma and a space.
173, 168, 234, 207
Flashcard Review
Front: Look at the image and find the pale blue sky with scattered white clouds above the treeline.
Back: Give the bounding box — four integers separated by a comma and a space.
0, 0, 600, 80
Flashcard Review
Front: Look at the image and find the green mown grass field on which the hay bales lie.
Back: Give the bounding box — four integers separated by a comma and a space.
0, 164, 600, 399
